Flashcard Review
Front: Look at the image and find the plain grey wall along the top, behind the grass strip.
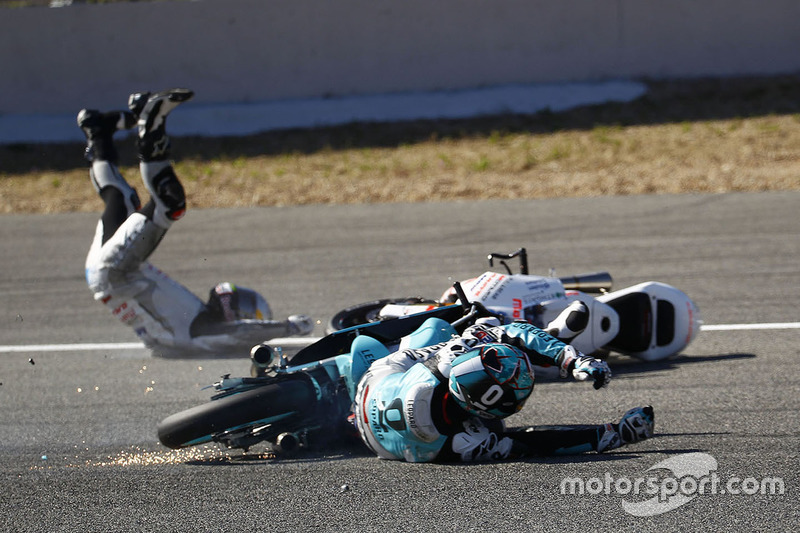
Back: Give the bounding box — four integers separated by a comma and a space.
0, 0, 800, 115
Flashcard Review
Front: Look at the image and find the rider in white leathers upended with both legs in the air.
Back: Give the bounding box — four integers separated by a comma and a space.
78, 89, 314, 357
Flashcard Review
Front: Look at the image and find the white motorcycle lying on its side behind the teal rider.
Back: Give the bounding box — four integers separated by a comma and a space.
327, 248, 701, 361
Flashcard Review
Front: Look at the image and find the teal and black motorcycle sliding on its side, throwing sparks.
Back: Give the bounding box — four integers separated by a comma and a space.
158, 289, 494, 454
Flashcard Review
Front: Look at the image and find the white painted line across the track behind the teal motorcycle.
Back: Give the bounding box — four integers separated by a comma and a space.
0, 322, 800, 353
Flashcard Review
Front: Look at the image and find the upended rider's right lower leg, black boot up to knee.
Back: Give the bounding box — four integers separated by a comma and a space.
133, 89, 194, 228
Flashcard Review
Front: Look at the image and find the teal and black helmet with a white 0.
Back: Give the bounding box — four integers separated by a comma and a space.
448, 344, 533, 418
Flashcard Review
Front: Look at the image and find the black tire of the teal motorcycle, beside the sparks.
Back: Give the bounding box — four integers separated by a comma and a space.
158, 379, 316, 449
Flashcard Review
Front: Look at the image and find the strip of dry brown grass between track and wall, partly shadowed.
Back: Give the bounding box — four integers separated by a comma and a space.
0, 77, 800, 213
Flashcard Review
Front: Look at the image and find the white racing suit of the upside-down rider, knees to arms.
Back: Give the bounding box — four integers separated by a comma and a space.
86, 213, 296, 357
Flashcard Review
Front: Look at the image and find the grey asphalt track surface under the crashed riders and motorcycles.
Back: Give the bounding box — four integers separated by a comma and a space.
0, 193, 800, 531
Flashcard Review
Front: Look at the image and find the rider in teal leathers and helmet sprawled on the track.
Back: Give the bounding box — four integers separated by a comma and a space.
354, 319, 654, 462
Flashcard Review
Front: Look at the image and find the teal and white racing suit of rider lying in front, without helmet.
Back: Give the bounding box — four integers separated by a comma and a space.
354, 322, 614, 462
